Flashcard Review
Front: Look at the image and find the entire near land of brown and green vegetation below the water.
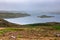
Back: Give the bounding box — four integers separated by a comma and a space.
0, 19, 60, 40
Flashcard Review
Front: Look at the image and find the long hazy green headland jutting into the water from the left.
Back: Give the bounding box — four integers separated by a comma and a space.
0, 11, 30, 18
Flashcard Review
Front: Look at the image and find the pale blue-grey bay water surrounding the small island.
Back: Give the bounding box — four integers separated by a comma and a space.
5, 12, 60, 24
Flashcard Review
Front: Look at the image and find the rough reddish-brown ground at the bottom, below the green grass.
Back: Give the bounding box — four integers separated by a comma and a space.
0, 27, 60, 40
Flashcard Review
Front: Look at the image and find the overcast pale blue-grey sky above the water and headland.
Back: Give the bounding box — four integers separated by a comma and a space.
0, 0, 60, 10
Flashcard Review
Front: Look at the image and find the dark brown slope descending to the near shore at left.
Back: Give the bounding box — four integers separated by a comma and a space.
0, 18, 21, 27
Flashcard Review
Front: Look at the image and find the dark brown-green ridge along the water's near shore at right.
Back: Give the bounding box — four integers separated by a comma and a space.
27, 22, 60, 26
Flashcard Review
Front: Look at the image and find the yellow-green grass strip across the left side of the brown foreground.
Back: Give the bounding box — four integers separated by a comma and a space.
0, 27, 33, 35
